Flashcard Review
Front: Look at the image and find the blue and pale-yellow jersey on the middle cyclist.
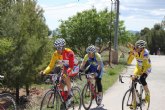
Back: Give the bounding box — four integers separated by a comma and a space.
83, 53, 103, 78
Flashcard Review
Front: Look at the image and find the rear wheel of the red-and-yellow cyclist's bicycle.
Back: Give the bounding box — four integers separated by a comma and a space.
72, 86, 81, 110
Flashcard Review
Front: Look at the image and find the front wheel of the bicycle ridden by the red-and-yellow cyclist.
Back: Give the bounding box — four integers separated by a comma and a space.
40, 90, 65, 110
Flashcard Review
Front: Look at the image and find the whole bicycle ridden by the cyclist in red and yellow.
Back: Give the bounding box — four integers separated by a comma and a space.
40, 69, 81, 110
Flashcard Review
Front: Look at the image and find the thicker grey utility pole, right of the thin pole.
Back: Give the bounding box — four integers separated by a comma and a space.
114, 0, 119, 64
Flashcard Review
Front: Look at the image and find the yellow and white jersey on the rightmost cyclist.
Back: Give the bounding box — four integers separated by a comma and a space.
127, 45, 151, 75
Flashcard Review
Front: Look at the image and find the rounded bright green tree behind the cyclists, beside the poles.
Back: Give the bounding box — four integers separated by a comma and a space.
56, 7, 125, 56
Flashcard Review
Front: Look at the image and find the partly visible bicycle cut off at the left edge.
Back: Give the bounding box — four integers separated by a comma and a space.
0, 75, 17, 110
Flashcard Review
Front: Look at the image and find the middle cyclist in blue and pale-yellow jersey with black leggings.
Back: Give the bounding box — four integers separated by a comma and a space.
80, 45, 103, 104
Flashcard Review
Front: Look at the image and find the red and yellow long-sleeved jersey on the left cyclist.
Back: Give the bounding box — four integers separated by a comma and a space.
44, 48, 79, 74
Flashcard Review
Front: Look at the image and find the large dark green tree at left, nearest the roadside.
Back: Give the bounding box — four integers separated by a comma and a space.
0, 0, 51, 101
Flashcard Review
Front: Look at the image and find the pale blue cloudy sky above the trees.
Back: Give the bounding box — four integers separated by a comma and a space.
38, 0, 165, 31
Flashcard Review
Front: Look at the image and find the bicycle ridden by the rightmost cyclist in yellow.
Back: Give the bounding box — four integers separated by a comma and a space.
119, 75, 150, 110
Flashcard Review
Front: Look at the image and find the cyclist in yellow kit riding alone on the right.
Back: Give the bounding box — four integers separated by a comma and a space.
127, 40, 151, 108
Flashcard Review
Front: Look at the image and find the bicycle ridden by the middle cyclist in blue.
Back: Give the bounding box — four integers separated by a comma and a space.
81, 65, 103, 110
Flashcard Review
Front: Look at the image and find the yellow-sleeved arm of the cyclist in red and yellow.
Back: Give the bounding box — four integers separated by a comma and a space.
43, 52, 57, 74
